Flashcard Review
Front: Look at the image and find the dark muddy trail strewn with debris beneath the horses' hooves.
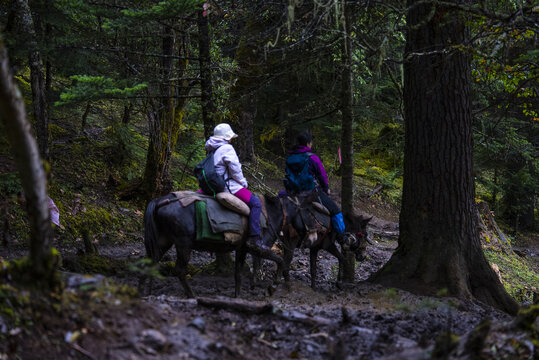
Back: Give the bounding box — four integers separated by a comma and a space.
23, 224, 536, 359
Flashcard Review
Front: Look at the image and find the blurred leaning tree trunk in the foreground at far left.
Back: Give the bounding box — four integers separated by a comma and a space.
0, 38, 55, 285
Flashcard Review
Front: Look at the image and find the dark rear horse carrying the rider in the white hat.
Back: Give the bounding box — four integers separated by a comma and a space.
144, 194, 317, 297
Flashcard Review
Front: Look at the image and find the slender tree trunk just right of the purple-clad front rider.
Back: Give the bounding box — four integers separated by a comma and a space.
341, 0, 355, 282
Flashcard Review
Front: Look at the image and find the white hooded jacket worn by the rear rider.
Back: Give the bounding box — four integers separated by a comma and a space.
206, 136, 248, 194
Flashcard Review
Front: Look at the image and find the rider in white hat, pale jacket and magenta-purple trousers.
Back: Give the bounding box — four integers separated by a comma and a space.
205, 123, 269, 250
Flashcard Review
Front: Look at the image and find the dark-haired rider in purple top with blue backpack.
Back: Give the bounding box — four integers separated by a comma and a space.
284, 131, 345, 235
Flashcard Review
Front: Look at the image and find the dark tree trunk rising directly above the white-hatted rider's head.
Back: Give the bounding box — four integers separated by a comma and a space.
197, 11, 215, 139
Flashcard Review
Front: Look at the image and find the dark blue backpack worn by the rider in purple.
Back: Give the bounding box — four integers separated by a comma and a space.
284, 152, 314, 193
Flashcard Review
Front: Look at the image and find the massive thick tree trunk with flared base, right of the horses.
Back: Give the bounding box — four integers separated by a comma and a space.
372, 0, 518, 314
